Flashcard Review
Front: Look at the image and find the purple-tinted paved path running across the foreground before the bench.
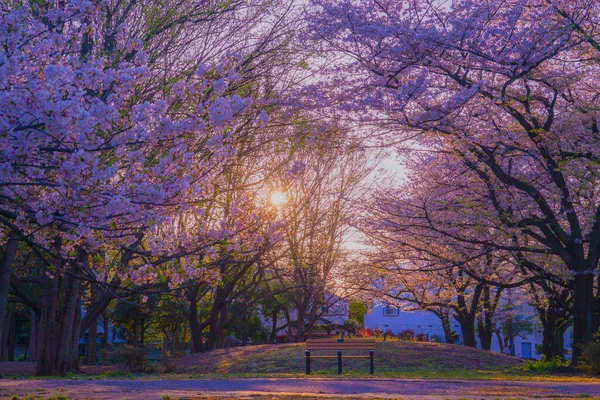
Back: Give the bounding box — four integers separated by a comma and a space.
0, 379, 600, 400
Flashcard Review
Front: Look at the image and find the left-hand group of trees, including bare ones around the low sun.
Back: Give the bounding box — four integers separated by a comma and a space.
0, 0, 369, 375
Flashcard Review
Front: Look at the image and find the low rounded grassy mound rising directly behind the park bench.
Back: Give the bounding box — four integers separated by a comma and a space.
178, 341, 525, 378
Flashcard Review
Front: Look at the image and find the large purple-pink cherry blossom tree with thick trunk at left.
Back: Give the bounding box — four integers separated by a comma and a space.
0, 1, 298, 374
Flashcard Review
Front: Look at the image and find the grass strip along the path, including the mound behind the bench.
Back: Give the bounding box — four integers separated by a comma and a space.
2, 341, 599, 382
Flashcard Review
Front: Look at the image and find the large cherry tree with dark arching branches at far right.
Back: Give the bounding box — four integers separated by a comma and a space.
311, 0, 600, 363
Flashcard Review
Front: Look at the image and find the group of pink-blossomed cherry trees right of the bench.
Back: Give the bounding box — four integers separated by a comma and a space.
311, 0, 600, 362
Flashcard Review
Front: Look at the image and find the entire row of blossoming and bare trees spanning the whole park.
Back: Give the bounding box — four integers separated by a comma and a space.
0, 0, 600, 374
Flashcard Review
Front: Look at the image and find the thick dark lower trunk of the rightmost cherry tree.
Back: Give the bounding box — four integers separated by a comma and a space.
571, 273, 596, 366
